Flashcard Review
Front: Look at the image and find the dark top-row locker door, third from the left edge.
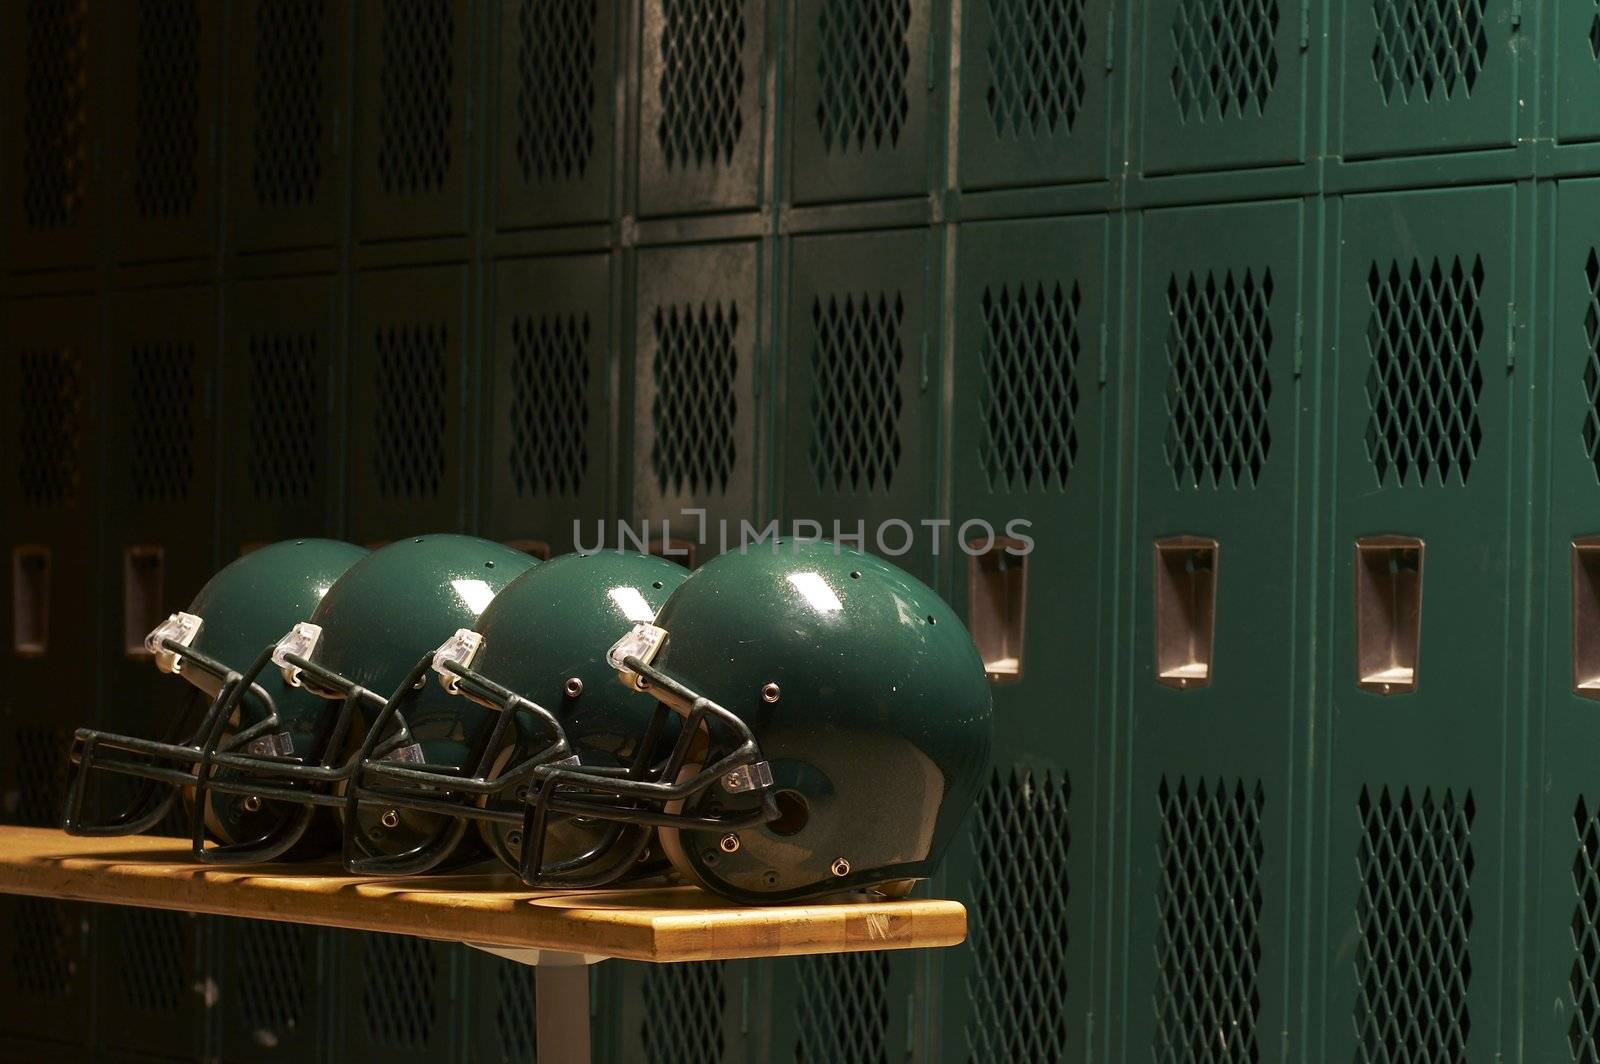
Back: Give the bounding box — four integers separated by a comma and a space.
227, 0, 350, 251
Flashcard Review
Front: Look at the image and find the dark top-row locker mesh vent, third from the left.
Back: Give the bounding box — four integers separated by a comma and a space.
250, 0, 328, 208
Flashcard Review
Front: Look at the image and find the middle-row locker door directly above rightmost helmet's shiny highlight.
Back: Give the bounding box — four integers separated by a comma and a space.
774, 230, 949, 584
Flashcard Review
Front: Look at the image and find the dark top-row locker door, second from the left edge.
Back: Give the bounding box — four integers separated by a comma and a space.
107, 0, 222, 262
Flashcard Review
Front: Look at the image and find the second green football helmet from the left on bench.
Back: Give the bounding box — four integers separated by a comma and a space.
184, 534, 536, 862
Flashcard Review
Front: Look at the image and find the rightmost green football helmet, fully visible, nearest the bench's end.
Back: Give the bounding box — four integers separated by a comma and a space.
525, 541, 990, 904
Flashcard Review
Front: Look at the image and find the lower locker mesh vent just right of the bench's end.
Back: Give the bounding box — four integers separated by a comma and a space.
966, 768, 1077, 1064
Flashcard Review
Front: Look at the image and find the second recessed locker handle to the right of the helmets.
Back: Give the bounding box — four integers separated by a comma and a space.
1155, 536, 1221, 690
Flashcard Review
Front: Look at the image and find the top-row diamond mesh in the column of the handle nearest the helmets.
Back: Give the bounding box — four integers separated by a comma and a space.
986, 0, 1090, 141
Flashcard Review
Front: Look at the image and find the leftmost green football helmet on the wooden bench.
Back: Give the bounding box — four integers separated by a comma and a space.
62, 539, 366, 850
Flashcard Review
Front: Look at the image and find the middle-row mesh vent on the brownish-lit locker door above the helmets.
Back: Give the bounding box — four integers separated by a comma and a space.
650, 302, 739, 494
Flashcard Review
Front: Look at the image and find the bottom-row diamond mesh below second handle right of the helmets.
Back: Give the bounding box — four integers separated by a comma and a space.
1154, 778, 1266, 1064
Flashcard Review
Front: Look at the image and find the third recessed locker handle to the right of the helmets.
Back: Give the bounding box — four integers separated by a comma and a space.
1355, 536, 1422, 694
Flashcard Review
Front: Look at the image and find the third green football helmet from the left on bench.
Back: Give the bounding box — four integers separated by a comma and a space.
412, 552, 688, 886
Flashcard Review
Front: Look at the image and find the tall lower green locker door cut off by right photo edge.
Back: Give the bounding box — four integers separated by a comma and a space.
1525, 181, 1600, 1061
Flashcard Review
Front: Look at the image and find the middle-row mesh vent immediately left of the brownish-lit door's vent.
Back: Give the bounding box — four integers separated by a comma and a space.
507, 314, 589, 498
